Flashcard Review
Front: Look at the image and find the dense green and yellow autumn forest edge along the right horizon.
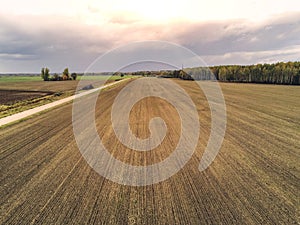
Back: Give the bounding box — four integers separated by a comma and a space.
132, 62, 300, 85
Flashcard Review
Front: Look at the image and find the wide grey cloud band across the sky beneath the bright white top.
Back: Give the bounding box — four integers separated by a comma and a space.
0, 13, 300, 72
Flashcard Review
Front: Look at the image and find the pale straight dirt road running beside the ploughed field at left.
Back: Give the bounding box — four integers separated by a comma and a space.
0, 78, 128, 127
